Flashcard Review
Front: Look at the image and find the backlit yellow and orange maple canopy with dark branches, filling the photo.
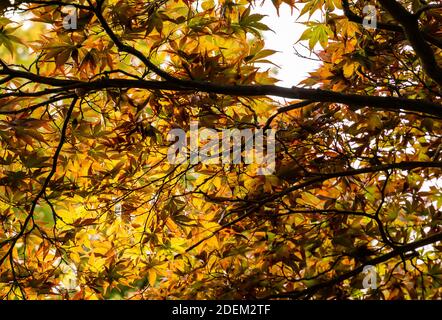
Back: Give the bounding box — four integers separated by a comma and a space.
0, 0, 442, 299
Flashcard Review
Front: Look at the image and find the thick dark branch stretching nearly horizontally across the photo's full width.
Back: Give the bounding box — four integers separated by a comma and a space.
0, 69, 442, 117
